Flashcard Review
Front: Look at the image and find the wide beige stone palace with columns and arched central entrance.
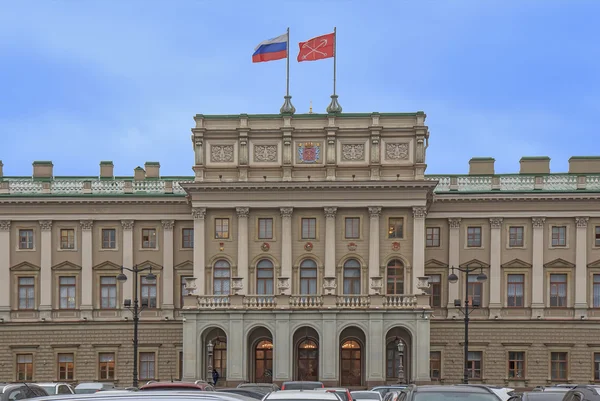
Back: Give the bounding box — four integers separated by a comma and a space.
0, 112, 600, 388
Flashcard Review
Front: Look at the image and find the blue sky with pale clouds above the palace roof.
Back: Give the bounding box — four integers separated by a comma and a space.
0, 0, 600, 175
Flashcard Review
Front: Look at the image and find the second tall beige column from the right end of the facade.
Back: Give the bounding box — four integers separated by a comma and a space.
531, 217, 546, 319
